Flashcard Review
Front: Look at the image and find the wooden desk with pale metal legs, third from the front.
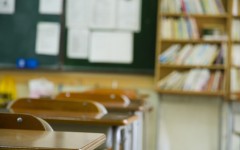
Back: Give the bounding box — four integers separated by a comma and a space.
52, 95, 151, 150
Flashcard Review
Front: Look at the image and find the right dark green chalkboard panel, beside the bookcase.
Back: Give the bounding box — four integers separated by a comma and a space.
64, 0, 157, 73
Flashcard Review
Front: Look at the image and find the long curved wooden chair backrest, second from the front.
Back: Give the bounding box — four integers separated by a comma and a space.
8, 98, 107, 117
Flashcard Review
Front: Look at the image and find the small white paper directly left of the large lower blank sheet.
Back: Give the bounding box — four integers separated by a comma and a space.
67, 29, 89, 59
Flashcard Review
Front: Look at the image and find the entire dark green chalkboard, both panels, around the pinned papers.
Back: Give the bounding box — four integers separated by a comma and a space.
0, 0, 157, 73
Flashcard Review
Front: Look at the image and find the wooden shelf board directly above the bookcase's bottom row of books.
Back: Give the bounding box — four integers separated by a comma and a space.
159, 64, 225, 70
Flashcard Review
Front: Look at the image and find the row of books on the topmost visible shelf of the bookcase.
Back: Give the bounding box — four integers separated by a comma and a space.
161, 0, 225, 15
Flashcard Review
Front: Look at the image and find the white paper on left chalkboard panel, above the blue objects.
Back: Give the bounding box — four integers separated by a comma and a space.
36, 22, 61, 55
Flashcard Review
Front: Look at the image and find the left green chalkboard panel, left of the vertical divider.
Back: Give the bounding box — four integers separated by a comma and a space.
0, 0, 61, 68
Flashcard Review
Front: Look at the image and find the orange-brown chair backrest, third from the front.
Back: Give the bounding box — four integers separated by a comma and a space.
55, 92, 130, 107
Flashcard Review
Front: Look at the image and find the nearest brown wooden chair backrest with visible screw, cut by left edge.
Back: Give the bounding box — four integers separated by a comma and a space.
0, 113, 53, 131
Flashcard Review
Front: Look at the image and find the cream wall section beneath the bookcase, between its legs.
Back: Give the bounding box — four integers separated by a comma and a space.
158, 95, 221, 150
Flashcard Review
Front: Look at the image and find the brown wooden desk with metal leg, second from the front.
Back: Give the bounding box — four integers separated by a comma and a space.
11, 109, 138, 150
